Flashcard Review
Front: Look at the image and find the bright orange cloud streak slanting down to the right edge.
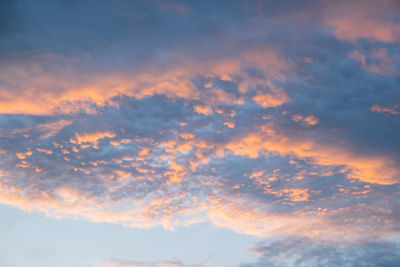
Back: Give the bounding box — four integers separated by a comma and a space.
225, 125, 400, 184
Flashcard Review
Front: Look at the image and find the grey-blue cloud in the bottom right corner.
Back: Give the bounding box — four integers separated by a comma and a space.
242, 239, 400, 267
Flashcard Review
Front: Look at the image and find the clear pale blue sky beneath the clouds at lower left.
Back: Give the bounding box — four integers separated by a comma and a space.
0, 205, 261, 267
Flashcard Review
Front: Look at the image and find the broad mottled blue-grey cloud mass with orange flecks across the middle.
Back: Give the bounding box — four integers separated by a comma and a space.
0, 93, 398, 240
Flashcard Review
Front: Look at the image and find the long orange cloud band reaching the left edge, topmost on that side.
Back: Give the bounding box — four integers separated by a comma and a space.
0, 47, 292, 115
